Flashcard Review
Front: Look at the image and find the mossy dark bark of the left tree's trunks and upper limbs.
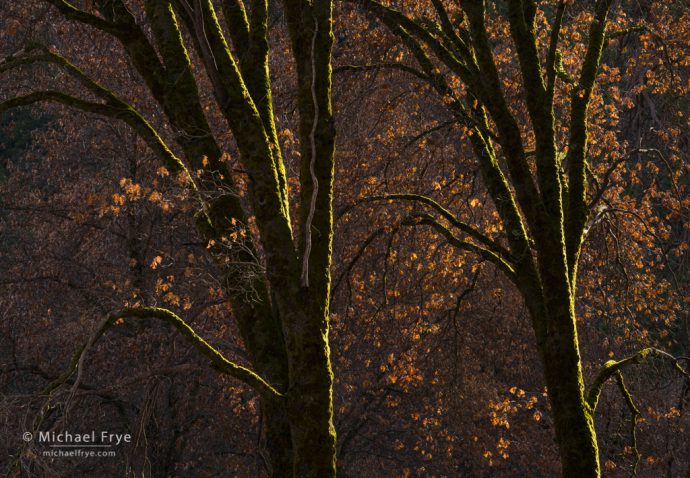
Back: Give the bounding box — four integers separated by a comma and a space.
0, 0, 335, 477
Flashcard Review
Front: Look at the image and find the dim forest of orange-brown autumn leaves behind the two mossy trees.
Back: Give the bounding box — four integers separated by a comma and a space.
0, 0, 690, 478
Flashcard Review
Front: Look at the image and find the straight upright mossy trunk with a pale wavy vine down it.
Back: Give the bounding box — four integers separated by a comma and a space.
281, 0, 336, 478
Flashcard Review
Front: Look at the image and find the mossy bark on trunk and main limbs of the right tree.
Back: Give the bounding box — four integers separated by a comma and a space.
349, 0, 612, 478
